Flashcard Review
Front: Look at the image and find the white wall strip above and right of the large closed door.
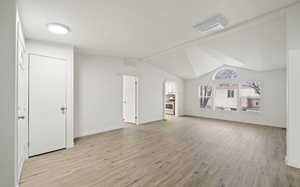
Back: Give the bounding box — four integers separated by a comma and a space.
26, 40, 74, 148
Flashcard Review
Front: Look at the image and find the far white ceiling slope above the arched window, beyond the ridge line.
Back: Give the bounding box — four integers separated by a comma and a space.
146, 11, 286, 79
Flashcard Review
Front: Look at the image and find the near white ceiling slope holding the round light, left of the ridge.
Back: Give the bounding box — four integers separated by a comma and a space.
18, 0, 297, 58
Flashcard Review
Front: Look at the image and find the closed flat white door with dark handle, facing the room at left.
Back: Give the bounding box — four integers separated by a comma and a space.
29, 55, 66, 156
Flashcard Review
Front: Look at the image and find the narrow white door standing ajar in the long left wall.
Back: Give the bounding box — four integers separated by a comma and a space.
123, 76, 137, 123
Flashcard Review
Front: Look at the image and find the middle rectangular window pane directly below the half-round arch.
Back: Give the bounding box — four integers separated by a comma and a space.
214, 83, 238, 111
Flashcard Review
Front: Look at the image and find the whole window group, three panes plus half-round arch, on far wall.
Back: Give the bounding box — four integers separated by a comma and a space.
199, 68, 262, 112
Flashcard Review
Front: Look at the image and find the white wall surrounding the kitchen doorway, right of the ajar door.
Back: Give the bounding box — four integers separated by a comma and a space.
136, 63, 184, 123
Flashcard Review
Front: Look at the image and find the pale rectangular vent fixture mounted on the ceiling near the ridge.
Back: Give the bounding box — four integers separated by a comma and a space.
193, 14, 228, 34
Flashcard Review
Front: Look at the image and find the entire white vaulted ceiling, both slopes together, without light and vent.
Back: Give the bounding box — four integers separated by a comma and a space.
19, 0, 297, 78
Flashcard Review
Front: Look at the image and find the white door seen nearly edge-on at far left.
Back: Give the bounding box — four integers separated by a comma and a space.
17, 37, 28, 177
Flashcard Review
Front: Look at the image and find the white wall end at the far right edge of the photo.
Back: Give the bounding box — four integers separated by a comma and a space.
286, 4, 300, 168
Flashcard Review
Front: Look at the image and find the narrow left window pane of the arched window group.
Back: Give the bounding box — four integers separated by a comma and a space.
199, 85, 213, 109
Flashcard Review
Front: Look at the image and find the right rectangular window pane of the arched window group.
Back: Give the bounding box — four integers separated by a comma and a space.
240, 81, 261, 112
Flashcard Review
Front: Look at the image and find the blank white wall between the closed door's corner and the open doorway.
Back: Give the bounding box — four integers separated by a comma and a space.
75, 55, 123, 137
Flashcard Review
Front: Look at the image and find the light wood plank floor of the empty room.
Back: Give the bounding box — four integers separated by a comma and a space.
20, 117, 300, 187
